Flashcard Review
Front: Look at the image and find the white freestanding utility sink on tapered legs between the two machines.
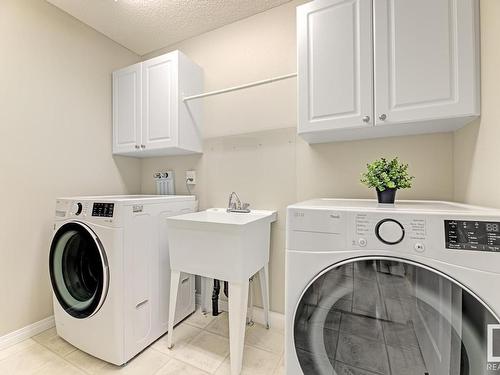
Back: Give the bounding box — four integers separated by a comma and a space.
167, 208, 276, 375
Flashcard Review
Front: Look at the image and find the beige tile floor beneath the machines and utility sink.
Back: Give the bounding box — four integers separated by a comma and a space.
0, 311, 285, 375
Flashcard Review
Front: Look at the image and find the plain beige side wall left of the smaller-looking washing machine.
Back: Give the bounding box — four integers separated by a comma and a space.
0, 0, 141, 336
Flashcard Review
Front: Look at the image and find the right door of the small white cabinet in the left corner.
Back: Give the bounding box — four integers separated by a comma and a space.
142, 54, 178, 150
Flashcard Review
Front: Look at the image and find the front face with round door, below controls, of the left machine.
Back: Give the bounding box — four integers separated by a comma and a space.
49, 220, 125, 364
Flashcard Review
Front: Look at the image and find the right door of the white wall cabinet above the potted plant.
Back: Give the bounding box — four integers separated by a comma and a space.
374, 0, 479, 124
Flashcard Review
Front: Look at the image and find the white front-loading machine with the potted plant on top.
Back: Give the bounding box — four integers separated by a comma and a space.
285, 199, 500, 375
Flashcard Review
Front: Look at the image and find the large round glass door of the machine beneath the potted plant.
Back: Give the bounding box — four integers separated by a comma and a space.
293, 258, 500, 375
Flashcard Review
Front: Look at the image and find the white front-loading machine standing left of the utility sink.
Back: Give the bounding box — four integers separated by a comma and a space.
49, 195, 197, 365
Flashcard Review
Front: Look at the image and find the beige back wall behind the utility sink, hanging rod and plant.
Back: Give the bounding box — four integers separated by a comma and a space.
142, 1, 453, 312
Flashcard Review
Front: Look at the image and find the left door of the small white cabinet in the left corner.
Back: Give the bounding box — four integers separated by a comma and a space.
113, 64, 141, 154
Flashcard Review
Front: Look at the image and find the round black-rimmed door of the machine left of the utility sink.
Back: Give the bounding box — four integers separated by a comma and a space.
49, 222, 109, 319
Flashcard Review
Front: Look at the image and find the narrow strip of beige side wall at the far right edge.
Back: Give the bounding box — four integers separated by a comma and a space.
454, 0, 500, 207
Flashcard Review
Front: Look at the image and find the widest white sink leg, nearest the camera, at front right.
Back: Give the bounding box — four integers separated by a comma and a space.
228, 281, 249, 375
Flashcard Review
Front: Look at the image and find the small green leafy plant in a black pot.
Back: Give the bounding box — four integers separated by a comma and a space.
361, 158, 414, 203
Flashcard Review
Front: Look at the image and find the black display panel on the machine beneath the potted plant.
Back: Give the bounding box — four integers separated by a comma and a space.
444, 220, 500, 252
